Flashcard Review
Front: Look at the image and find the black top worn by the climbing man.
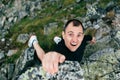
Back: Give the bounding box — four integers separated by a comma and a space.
54, 35, 92, 62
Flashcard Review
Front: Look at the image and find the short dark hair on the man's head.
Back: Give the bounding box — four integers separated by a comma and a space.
63, 19, 84, 31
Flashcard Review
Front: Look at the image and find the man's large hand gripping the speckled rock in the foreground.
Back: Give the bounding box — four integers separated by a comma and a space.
42, 52, 65, 74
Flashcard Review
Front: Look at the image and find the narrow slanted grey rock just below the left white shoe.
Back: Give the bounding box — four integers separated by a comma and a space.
13, 48, 34, 80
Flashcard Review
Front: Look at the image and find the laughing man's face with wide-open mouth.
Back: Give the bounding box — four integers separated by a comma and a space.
62, 22, 84, 52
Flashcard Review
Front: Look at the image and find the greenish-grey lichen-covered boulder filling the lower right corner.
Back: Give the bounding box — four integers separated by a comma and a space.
82, 49, 120, 80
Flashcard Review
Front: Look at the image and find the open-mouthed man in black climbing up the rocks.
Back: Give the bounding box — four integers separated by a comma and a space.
28, 19, 95, 74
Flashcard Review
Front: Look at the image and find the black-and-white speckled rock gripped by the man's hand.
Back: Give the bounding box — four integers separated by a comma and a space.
18, 61, 84, 80
